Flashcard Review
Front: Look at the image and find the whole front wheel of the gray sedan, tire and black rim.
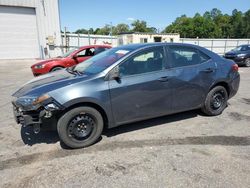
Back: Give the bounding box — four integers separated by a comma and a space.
57, 107, 103, 148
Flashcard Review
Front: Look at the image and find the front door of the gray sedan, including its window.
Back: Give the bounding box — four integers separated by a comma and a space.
109, 46, 172, 124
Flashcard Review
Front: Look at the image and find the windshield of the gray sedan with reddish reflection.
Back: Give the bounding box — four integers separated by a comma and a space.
74, 47, 132, 74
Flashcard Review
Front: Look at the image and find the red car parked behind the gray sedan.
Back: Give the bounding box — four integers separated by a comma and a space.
31, 45, 111, 76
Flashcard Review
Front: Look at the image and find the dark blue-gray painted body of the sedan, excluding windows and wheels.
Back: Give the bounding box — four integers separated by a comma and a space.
14, 43, 239, 127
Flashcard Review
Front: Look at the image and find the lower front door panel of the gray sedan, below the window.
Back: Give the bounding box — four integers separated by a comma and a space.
109, 71, 172, 124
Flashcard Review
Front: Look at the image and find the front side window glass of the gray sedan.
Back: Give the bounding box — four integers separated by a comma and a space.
119, 47, 164, 76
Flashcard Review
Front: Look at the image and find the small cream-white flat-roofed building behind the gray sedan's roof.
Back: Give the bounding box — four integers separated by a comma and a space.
118, 32, 180, 45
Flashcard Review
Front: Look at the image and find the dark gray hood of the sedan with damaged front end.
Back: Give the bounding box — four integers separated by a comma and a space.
12, 69, 91, 98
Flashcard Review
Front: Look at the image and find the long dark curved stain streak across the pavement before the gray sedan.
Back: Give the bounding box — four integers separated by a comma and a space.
0, 136, 250, 170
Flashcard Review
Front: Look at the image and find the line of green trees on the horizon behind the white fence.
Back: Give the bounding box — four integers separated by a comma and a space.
72, 8, 250, 38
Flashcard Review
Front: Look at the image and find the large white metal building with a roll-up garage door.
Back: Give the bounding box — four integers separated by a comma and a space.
0, 0, 62, 59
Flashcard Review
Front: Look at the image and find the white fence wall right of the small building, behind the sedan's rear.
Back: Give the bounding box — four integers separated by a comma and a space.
180, 38, 250, 55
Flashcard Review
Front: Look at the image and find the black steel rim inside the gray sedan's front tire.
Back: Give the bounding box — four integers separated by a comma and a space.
67, 114, 95, 141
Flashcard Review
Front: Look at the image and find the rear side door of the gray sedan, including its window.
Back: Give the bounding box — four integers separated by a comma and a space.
168, 45, 214, 111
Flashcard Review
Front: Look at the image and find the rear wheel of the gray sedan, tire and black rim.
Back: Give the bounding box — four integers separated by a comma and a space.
201, 86, 228, 116
